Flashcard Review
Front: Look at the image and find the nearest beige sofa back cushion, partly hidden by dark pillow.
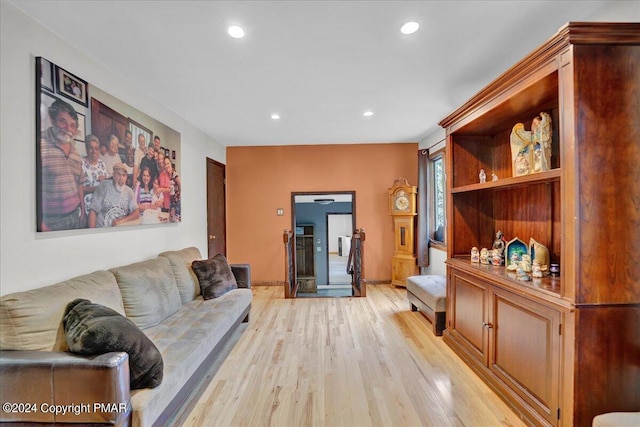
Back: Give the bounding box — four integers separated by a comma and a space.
0, 271, 125, 351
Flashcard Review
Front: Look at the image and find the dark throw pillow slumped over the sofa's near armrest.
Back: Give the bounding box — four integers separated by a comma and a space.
63, 298, 164, 390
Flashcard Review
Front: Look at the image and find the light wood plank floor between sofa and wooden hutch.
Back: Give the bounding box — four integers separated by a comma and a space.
181, 285, 524, 427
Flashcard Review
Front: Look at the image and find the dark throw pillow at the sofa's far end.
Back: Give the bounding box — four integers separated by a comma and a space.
191, 254, 238, 300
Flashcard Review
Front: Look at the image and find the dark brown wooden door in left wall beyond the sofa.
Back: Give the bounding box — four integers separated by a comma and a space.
207, 158, 227, 258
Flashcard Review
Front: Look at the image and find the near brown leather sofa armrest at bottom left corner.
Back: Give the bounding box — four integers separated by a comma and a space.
0, 350, 131, 425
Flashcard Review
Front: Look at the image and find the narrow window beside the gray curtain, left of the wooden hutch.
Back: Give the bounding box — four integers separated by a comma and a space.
429, 150, 447, 245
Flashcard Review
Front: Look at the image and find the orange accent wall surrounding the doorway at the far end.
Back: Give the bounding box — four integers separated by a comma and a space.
226, 143, 418, 282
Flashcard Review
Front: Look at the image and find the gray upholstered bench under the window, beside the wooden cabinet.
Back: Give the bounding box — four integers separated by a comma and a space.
407, 275, 447, 336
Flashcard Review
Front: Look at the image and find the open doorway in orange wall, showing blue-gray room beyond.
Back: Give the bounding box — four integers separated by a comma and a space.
291, 191, 356, 297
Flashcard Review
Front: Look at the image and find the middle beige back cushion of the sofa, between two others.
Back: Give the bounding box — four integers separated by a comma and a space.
110, 257, 182, 329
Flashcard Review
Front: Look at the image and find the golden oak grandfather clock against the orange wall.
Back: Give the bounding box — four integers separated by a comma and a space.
389, 178, 418, 286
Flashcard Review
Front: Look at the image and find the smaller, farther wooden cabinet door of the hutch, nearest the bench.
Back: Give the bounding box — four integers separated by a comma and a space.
447, 269, 488, 366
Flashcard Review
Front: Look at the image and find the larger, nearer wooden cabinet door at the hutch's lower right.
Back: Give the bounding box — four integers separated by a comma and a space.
489, 288, 561, 425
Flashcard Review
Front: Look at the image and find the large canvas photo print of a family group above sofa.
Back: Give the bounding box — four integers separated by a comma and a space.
36, 57, 182, 232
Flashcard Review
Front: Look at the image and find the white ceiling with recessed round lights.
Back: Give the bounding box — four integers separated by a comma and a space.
10, 0, 611, 146
